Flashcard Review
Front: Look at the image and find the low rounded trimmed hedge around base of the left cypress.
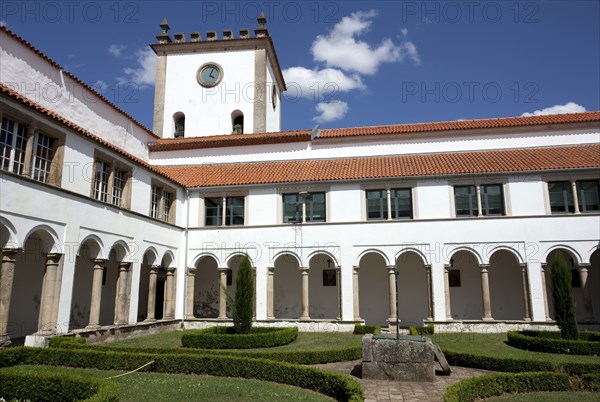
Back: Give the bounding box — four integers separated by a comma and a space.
181, 327, 298, 349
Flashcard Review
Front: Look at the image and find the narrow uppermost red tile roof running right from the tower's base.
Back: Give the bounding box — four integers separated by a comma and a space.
148, 111, 600, 152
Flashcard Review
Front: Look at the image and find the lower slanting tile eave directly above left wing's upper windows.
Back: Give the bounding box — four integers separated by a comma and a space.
0, 83, 183, 185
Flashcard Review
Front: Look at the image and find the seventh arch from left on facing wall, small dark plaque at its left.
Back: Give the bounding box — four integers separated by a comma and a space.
448, 250, 483, 320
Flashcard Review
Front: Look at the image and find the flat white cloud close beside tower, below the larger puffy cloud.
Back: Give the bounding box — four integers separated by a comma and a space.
283, 67, 365, 101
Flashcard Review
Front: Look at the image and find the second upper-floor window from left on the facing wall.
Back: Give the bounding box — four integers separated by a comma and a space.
283, 192, 327, 223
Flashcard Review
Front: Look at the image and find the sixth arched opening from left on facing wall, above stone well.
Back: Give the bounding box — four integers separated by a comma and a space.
396, 251, 429, 327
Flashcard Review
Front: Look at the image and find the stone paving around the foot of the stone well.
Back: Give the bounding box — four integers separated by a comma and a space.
314, 360, 493, 402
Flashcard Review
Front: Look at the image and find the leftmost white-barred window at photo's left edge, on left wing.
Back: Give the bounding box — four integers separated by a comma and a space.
0, 118, 27, 174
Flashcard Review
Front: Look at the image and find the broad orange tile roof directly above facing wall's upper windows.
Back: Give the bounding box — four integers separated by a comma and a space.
154, 144, 600, 187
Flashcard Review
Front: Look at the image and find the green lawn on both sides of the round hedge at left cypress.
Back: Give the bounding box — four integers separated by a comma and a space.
110, 331, 362, 351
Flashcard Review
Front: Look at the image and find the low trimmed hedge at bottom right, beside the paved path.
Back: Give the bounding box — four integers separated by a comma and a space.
444, 373, 572, 402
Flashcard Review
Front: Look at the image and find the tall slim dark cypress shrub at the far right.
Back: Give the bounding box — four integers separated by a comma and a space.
550, 251, 578, 339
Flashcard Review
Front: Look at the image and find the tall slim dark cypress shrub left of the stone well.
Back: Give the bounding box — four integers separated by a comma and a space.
232, 256, 254, 334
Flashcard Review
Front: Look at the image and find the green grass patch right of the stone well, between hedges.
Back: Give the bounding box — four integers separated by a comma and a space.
430, 333, 600, 363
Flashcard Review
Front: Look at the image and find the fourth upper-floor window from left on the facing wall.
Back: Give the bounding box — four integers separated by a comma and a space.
454, 184, 504, 216
